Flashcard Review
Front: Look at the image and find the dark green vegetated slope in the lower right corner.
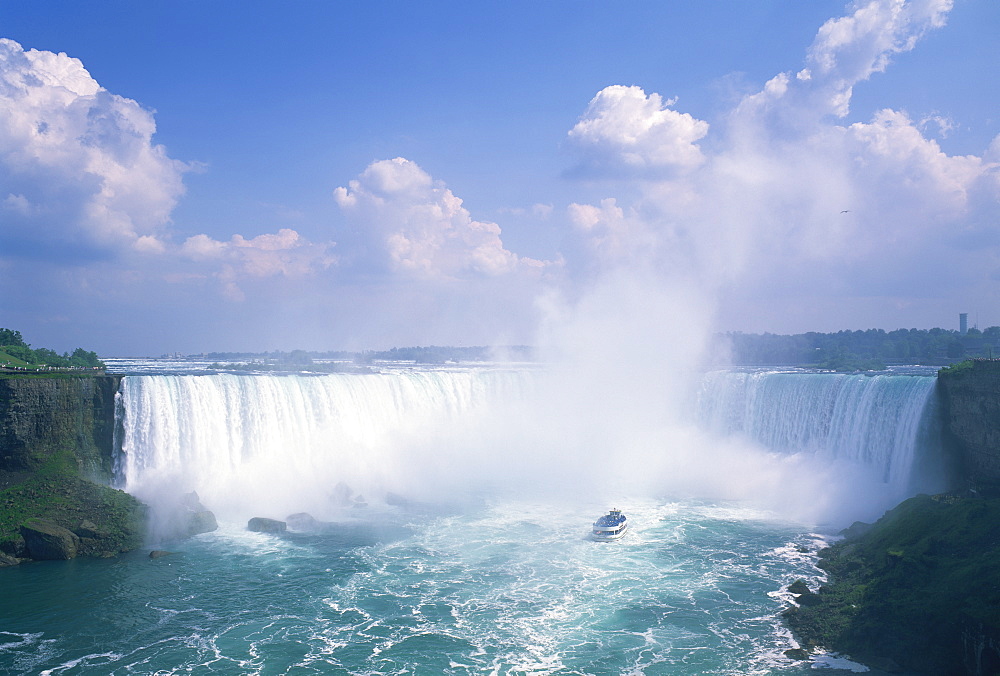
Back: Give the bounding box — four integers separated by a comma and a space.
785, 495, 1000, 674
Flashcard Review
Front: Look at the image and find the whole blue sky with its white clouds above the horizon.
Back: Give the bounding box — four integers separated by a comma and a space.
0, 0, 1000, 356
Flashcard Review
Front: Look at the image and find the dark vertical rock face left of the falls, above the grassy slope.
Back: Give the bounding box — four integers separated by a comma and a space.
0, 376, 121, 482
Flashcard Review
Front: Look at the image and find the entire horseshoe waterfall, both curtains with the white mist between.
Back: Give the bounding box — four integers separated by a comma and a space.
117, 368, 934, 518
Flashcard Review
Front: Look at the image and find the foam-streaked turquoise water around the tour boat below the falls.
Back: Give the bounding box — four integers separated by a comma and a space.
0, 502, 852, 674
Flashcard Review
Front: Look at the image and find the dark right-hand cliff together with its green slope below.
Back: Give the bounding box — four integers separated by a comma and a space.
785, 359, 1000, 676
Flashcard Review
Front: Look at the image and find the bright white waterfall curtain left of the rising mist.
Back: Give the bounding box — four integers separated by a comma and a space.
116, 369, 531, 511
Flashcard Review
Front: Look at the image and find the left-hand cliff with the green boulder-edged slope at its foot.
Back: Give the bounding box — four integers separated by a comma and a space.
0, 376, 146, 566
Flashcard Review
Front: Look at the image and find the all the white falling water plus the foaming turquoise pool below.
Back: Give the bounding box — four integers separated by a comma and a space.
0, 368, 935, 675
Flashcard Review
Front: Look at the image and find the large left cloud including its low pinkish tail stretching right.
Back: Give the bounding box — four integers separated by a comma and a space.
0, 39, 335, 300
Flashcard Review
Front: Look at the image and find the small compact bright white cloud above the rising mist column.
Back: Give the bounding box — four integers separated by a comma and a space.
569, 85, 708, 174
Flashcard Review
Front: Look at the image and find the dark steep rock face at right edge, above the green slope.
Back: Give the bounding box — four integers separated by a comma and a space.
938, 359, 1000, 490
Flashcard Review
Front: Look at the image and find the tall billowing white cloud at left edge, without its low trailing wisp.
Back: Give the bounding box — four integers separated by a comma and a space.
0, 39, 190, 257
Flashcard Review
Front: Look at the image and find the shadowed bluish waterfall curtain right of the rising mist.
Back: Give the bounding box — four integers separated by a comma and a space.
698, 371, 939, 497
